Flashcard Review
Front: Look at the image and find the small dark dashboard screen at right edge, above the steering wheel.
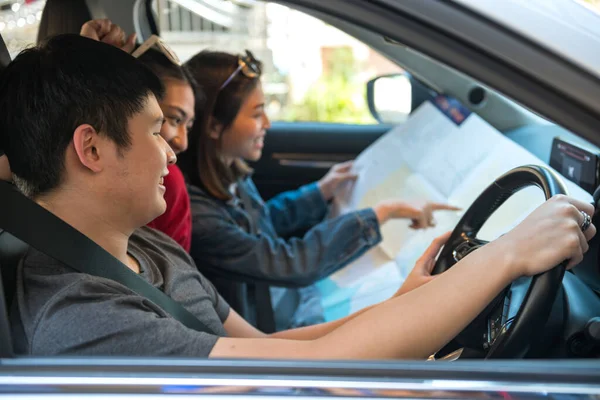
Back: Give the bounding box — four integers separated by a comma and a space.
550, 138, 598, 193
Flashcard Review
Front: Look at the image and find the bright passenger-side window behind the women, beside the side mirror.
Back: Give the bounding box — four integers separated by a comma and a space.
155, 0, 410, 124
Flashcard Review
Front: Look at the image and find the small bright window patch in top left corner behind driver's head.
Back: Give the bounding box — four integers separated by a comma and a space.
0, 0, 46, 58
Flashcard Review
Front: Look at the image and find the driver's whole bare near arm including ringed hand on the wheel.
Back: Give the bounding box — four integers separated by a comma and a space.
210, 196, 596, 359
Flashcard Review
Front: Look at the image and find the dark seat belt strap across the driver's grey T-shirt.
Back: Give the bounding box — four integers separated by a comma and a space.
0, 181, 215, 334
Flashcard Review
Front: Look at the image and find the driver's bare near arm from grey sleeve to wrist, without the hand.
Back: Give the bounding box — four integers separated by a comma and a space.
210, 238, 511, 359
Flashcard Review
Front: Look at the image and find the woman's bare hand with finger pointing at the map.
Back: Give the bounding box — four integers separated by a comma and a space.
374, 200, 460, 229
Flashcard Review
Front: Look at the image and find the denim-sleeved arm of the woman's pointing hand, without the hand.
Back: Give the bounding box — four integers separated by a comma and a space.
191, 205, 381, 286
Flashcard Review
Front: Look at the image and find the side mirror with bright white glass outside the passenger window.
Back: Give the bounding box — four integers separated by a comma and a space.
367, 73, 436, 124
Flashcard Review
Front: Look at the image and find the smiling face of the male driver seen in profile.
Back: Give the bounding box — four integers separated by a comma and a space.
102, 95, 176, 229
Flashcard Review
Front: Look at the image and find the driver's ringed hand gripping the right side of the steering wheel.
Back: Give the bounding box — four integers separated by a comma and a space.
496, 195, 596, 279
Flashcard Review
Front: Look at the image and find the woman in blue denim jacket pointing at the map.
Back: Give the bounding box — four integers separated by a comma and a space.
180, 51, 456, 330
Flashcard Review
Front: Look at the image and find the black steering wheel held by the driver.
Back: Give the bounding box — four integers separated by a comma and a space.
433, 165, 566, 358
